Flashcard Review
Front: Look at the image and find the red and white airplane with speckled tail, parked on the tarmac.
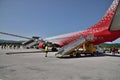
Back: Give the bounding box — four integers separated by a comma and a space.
39, 0, 120, 48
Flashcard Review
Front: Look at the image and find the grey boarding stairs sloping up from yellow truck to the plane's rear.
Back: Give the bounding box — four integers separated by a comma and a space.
55, 35, 93, 57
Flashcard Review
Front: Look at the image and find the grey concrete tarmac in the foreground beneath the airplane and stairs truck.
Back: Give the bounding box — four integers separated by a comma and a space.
0, 49, 120, 80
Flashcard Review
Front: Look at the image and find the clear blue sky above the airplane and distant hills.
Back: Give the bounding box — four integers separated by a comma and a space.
0, 0, 120, 42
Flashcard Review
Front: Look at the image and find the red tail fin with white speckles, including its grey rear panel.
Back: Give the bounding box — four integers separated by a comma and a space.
88, 0, 120, 31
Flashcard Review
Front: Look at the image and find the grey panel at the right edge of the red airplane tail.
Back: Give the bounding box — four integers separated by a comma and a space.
109, 0, 120, 31
